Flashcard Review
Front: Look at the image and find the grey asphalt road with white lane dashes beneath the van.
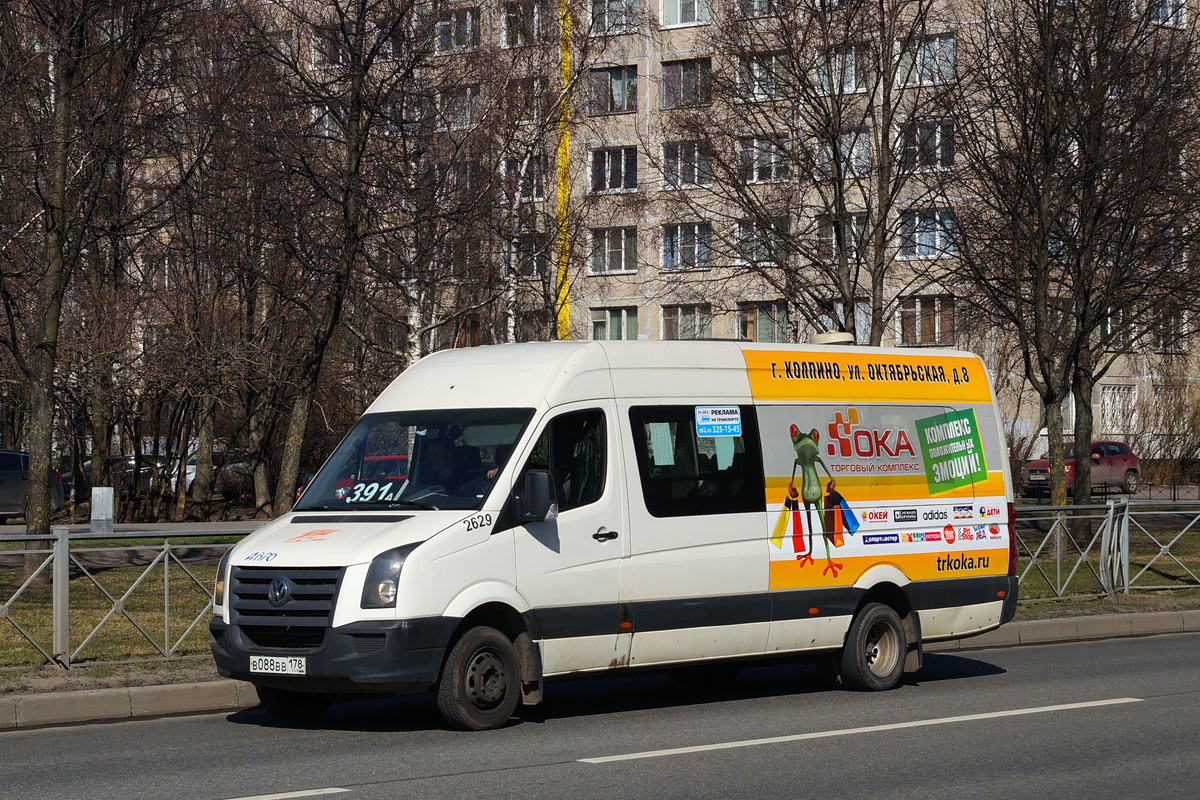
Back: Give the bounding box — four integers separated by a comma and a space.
0, 634, 1200, 800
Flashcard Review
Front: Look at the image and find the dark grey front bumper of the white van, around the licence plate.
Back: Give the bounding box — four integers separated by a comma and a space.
209, 616, 460, 693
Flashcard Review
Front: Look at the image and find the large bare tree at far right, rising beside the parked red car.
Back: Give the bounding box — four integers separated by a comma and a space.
944, 0, 1198, 504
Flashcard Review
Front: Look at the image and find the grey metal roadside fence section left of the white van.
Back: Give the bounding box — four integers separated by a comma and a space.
0, 527, 251, 669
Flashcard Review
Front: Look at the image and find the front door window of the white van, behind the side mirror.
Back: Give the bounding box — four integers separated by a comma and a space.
517, 409, 607, 512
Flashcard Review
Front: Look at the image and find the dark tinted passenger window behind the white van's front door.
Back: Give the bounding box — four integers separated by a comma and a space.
629, 405, 767, 517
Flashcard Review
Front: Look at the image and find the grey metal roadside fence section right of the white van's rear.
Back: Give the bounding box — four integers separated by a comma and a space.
1015, 498, 1200, 602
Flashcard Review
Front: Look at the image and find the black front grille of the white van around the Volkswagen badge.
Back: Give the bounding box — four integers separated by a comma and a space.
229, 566, 342, 650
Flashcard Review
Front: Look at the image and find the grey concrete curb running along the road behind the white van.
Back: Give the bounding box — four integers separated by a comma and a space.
0, 609, 1200, 732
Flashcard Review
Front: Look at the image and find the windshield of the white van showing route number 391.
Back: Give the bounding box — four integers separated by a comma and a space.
295, 408, 533, 511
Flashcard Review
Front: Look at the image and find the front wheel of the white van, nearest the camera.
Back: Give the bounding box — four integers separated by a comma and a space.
438, 627, 521, 730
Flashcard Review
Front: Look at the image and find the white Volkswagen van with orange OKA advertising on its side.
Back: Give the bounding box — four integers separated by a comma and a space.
210, 342, 1016, 729
